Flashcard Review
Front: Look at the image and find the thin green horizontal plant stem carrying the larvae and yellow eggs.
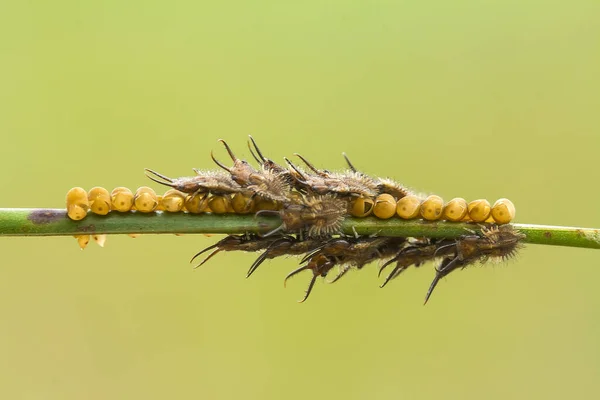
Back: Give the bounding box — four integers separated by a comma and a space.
0, 208, 600, 249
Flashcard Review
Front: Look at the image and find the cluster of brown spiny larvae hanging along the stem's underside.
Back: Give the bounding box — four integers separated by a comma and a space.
192, 225, 524, 303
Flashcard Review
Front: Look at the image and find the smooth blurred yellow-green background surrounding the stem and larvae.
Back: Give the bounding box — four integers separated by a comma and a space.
0, 0, 600, 399
